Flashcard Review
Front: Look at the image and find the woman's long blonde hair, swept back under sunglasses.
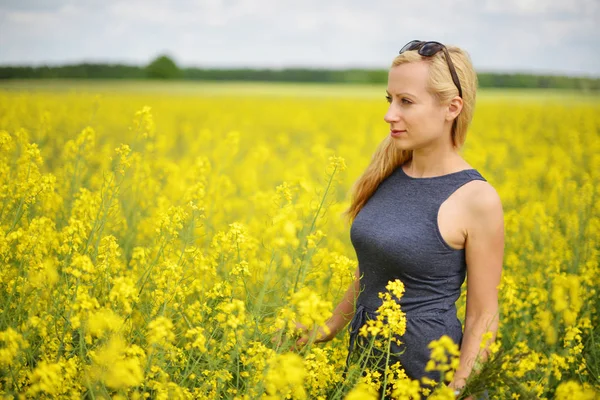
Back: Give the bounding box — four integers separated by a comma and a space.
343, 46, 477, 225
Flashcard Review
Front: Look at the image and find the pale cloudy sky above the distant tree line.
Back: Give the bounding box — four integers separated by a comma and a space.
0, 0, 600, 77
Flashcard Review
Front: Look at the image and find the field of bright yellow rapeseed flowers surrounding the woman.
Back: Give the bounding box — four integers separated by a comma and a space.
0, 81, 600, 399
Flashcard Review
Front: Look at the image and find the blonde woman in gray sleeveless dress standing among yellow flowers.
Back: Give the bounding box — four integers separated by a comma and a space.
296, 41, 504, 391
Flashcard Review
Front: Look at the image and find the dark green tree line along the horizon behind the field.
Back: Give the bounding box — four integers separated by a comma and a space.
0, 56, 600, 91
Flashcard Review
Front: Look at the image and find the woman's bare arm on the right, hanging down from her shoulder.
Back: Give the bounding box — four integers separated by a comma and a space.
450, 183, 504, 388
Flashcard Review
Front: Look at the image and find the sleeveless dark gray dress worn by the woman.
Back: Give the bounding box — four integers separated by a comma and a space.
345, 163, 485, 396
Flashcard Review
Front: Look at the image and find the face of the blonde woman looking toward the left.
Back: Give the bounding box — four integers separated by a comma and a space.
384, 62, 452, 150
